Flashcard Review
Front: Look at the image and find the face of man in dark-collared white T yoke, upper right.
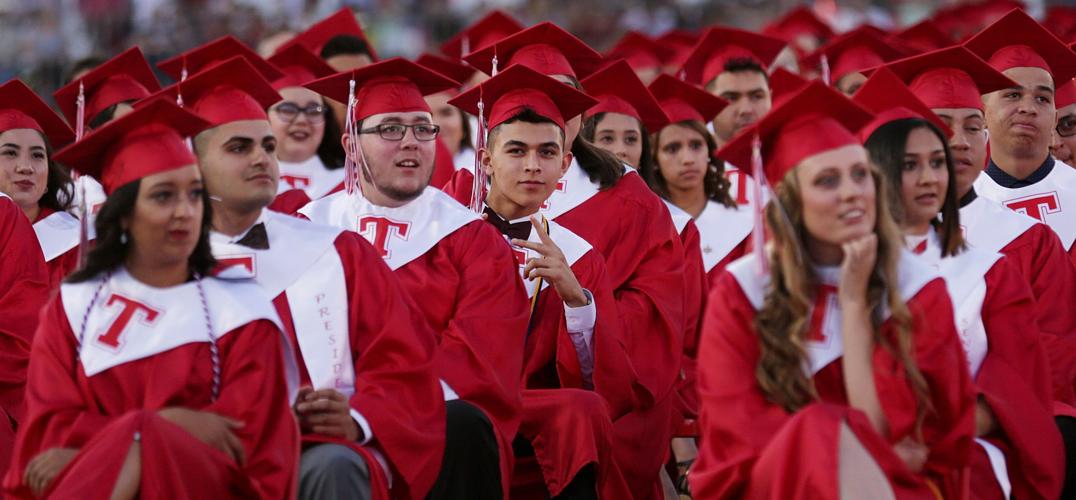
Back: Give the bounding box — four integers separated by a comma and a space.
983, 68, 1057, 159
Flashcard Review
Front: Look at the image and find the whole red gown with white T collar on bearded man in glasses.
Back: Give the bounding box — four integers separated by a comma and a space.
299, 187, 528, 495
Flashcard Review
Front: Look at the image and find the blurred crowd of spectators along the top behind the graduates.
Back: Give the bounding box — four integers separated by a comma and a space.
0, 0, 1058, 101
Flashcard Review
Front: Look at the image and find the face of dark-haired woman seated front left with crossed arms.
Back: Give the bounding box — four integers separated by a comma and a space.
124, 165, 204, 267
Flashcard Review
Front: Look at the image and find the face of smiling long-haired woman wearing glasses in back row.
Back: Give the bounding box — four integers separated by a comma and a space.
269, 87, 325, 163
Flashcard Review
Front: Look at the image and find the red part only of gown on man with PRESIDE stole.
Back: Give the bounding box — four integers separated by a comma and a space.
273, 231, 445, 499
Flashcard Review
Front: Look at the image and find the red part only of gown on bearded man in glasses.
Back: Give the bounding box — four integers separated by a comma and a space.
394, 220, 529, 495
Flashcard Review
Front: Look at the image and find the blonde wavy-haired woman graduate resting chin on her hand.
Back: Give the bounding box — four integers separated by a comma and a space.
689, 82, 975, 498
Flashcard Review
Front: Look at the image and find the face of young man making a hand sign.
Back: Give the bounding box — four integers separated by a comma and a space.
481, 122, 571, 214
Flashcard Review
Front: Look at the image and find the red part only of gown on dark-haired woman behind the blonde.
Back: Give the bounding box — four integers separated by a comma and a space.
972, 258, 1065, 499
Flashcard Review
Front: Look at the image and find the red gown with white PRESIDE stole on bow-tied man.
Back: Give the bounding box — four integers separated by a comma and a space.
211, 211, 444, 498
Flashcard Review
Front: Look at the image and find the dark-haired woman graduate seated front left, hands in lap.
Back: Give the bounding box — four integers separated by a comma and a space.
3, 100, 299, 499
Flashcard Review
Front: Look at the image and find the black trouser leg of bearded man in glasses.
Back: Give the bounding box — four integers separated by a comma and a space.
426, 399, 502, 500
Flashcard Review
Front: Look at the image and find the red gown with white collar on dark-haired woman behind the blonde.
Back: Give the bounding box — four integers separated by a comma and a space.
906, 231, 1064, 499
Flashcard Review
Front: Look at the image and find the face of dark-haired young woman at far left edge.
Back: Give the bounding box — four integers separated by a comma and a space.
0, 128, 48, 210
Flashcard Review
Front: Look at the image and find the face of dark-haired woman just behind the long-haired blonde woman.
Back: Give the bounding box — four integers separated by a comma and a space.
901, 127, 949, 228
